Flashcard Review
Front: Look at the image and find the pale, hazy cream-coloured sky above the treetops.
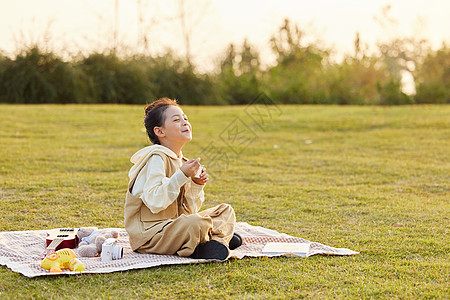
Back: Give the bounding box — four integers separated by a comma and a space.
0, 0, 450, 69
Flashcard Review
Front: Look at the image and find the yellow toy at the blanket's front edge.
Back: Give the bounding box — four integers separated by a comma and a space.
41, 248, 85, 273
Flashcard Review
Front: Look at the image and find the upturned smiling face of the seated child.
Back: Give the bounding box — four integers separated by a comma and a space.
161, 105, 192, 144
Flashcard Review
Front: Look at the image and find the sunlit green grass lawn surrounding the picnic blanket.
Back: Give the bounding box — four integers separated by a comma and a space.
0, 105, 450, 299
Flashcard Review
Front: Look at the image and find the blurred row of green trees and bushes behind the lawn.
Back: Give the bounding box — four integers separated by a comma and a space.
0, 19, 450, 105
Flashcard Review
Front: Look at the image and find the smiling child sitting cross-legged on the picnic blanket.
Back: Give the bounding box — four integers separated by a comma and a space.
125, 98, 242, 260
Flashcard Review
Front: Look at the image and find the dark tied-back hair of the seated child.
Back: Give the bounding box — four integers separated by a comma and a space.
144, 97, 179, 144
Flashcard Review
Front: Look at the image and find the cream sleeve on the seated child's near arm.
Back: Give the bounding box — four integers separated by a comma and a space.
133, 155, 189, 214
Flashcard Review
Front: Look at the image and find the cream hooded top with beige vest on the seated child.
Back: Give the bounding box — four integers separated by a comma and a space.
124, 145, 204, 250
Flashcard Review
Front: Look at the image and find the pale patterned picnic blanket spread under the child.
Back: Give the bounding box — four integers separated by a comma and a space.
0, 222, 358, 277
